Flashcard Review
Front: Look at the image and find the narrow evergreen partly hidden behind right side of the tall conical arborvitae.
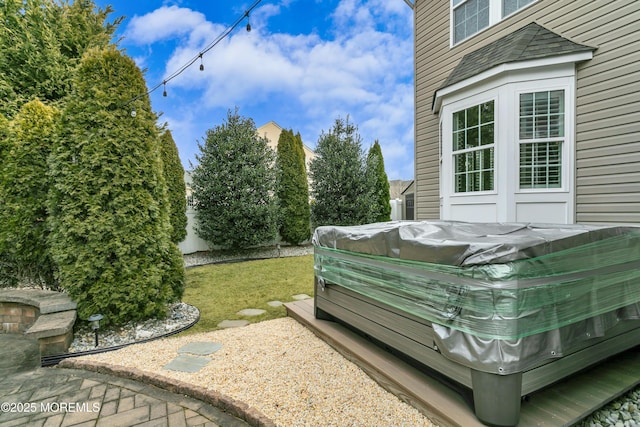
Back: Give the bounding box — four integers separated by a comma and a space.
160, 129, 187, 243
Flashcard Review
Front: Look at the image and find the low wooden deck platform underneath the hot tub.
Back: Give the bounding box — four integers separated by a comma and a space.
285, 300, 640, 427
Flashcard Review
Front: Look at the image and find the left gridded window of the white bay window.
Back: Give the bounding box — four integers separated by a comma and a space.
453, 101, 494, 193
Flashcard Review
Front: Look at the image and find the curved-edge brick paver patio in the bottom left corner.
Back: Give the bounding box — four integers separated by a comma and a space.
0, 368, 249, 427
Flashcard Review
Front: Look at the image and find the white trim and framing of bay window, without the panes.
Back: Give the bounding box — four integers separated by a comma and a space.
435, 61, 590, 226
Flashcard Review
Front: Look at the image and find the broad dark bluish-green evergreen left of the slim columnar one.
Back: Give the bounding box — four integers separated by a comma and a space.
192, 109, 277, 251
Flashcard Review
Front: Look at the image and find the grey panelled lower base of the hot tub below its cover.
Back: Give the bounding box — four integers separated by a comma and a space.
314, 282, 640, 426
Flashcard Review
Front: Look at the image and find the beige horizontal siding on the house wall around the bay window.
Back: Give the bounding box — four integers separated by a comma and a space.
415, 0, 640, 224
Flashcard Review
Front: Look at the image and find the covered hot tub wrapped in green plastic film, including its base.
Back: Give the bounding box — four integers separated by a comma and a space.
313, 221, 640, 426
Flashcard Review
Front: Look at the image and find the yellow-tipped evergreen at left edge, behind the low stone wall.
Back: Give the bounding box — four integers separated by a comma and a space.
0, 100, 57, 287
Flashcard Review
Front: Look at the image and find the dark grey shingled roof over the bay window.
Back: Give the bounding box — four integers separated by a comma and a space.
440, 22, 595, 89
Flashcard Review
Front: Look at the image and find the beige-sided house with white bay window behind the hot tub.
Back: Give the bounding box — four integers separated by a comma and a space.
412, 0, 640, 224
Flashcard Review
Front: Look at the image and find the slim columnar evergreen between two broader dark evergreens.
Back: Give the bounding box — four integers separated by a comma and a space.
276, 130, 311, 245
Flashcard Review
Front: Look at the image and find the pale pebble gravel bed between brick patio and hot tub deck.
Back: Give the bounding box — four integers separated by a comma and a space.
74, 318, 434, 427
